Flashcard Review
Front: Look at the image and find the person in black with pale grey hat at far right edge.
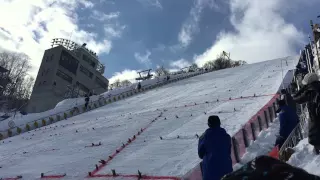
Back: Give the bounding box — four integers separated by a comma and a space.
293, 73, 320, 154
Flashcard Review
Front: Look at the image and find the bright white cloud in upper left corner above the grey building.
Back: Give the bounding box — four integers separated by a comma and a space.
0, 0, 112, 77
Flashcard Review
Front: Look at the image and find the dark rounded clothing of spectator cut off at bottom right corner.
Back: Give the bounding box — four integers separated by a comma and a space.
222, 156, 320, 180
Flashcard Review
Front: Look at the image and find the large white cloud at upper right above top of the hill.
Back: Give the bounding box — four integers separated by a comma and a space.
194, 0, 304, 66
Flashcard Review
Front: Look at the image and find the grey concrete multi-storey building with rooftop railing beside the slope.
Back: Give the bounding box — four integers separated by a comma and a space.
27, 38, 109, 113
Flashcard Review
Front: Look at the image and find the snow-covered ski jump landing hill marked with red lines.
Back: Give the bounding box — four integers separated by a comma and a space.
0, 57, 297, 179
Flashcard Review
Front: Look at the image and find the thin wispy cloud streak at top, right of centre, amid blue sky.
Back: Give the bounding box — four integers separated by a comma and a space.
178, 0, 218, 47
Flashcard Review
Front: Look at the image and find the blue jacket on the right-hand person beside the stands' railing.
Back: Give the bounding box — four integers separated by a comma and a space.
279, 106, 299, 139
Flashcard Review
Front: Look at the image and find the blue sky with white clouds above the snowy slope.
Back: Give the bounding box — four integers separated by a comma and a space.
0, 0, 320, 81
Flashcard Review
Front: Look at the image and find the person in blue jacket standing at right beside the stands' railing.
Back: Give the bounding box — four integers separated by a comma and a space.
275, 100, 299, 148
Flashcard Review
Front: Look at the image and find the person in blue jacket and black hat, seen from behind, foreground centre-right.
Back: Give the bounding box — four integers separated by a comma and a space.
198, 116, 233, 180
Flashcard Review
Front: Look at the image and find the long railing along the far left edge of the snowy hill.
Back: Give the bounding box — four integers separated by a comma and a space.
0, 71, 212, 140
